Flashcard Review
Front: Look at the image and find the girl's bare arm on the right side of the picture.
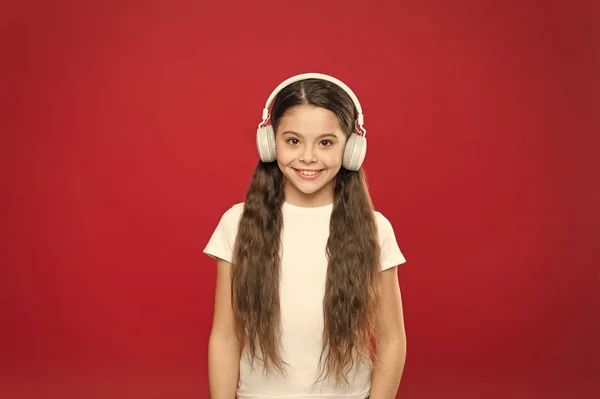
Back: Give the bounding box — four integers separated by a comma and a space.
370, 267, 406, 399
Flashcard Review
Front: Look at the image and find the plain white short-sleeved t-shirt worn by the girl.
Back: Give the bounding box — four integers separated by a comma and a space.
204, 202, 405, 399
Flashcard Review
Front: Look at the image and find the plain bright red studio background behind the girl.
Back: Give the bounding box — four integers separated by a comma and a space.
0, 0, 600, 399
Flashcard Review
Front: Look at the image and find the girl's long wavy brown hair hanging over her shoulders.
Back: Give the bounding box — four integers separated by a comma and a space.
232, 79, 380, 383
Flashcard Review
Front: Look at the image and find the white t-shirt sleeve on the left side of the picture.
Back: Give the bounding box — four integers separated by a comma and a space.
203, 204, 243, 263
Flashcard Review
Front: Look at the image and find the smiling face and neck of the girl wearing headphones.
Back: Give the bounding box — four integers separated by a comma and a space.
275, 105, 346, 206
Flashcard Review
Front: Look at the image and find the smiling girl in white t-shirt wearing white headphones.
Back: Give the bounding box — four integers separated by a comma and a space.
204, 74, 406, 399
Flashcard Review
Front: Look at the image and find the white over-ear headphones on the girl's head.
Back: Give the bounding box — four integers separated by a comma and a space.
256, 73, 367, 171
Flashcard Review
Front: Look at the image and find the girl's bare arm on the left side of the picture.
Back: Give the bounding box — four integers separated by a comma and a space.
208, 259, 240, 399
